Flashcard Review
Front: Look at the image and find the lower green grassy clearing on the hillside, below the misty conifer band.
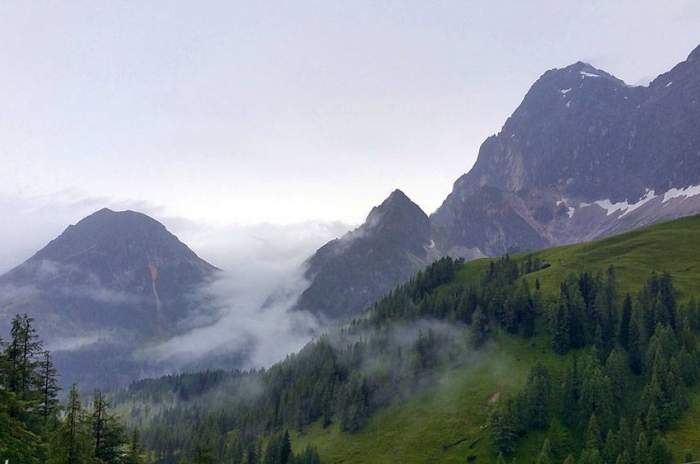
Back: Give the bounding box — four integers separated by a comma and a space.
294, 337, 556, 463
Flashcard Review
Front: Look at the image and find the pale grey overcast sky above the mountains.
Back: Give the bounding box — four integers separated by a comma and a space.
0, 0, 700, 230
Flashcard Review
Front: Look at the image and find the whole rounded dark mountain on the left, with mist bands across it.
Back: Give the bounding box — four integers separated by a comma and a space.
0, 209, 217, 384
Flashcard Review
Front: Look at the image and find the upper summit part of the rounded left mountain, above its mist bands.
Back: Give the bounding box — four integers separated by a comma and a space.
0, 208, 217, 292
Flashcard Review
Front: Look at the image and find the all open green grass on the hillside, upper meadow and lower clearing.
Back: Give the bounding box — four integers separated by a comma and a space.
293, 216, 700, 463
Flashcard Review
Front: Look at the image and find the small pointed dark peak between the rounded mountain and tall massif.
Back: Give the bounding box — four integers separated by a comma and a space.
297, 190, 435, 318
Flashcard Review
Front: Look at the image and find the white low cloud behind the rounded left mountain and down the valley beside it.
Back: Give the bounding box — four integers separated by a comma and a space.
0, 191, 351, 369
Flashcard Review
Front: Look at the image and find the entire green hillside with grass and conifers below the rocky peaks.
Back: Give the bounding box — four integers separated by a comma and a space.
114, 216, 700, 464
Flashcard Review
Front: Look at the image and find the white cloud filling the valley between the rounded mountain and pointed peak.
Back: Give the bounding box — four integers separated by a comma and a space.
146, 222, 348, 367
